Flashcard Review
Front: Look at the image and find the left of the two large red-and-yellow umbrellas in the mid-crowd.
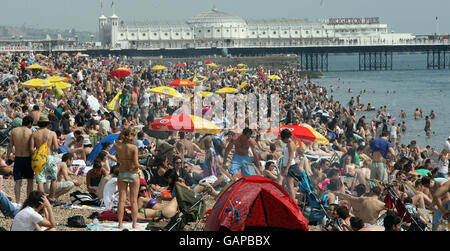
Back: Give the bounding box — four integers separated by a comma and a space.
150, 114, 222, 134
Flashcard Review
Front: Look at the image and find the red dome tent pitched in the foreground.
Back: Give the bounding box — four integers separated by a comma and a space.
206, 176, 308, 231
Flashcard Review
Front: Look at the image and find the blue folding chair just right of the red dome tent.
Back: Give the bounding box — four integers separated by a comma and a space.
295, 171, 329, 224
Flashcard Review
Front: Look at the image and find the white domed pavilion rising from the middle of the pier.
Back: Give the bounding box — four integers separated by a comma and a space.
186, 8, 248, 39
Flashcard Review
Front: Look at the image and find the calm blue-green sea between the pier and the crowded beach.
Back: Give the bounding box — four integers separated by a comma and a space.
315, 54, 450, 151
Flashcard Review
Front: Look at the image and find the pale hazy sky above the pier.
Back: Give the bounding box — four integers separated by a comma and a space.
0, 0, 450, 34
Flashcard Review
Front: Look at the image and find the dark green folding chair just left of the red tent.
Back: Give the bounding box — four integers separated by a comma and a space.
163, 185, 206, 231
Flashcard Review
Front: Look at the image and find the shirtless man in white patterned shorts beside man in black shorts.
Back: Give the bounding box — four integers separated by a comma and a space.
30, 114, 58, 204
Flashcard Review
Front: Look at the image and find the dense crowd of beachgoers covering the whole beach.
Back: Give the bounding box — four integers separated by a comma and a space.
0, 53, 450, 231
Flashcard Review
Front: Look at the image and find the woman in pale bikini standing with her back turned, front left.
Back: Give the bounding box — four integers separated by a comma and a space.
114, 128, 145, 229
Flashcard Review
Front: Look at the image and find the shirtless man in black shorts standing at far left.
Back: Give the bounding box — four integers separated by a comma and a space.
6, 116, 34, 203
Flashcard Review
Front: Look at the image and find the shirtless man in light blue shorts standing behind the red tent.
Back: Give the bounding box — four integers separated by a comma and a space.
223, 127, 263, 179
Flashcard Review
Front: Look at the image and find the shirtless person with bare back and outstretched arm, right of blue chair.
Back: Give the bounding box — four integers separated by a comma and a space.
336, 187, 385, 225
